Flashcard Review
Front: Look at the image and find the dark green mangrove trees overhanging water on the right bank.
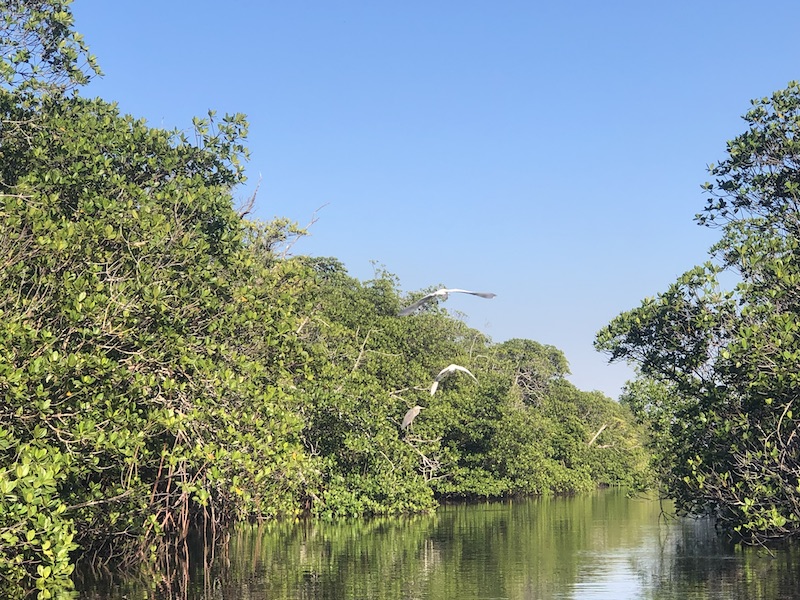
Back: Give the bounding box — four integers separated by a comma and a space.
597, 82, 800, 543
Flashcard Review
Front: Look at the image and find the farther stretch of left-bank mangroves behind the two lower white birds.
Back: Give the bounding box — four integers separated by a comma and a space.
294, 259, 647, 515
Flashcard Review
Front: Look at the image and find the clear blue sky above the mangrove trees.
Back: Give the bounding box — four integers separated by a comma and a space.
73, 0, 800, 398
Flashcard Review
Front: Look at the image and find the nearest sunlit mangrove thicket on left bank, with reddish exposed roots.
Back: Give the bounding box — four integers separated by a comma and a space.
0, 75, 307, 582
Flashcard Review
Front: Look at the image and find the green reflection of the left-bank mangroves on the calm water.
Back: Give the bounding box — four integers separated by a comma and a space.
214, 492, 659, 598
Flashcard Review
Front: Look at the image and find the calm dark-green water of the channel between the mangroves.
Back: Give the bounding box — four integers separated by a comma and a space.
78, 491, 800, 600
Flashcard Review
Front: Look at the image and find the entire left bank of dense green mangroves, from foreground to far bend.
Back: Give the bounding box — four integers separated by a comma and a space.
0, 0, 646, 598
